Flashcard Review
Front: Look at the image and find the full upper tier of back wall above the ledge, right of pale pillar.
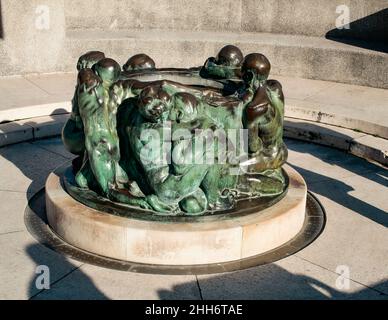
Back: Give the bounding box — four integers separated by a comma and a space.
65, 0, 388, 41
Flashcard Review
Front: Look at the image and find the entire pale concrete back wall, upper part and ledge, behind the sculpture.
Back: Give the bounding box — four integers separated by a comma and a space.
0, 0, 388, 87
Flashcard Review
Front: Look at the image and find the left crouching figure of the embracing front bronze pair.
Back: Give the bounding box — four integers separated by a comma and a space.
127, 85, 214, 214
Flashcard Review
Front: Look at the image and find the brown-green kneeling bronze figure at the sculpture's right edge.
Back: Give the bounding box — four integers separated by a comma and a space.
241, 53, 287, 172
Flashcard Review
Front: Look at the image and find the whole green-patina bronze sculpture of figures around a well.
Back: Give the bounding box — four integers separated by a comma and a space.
62, 45, 287, 216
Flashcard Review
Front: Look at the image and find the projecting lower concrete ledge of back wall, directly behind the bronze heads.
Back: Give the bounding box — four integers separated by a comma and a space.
62, 30, 388, 88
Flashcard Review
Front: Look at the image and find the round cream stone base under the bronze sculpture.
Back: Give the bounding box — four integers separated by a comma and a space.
46, 166, 307, 266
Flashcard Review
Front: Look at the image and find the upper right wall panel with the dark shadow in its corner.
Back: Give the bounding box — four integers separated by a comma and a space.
242, 0, 388, 40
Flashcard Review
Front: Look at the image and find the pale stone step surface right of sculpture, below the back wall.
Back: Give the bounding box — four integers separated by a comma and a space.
274, 76, 388, 139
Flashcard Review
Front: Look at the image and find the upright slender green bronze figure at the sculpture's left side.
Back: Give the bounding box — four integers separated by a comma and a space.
76, 58, 128, 199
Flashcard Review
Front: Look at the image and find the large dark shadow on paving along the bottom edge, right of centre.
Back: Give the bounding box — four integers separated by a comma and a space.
159, 264, 388, 300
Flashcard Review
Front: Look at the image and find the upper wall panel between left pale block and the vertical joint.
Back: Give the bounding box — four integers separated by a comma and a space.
65, 0, 244, 31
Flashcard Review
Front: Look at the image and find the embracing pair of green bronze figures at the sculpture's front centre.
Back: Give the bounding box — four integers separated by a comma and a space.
119, 81, 241, 214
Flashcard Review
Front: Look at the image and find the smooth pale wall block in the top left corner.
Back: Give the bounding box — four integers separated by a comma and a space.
0, 0, 66, 75
